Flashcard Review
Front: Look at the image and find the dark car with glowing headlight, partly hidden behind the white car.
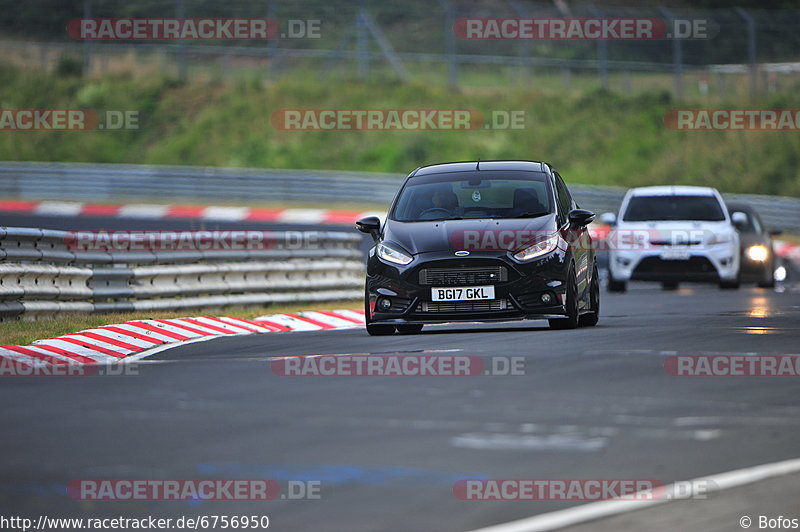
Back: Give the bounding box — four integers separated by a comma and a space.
726, 202, 781, 288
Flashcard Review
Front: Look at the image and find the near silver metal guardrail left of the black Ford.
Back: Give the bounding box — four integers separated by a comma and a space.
0, 227, 364, 321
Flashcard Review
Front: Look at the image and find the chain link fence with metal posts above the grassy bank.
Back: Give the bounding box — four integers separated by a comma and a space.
0, 0, 800, 97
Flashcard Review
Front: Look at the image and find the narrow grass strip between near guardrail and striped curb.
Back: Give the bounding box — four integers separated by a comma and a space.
0, 300, 364, 345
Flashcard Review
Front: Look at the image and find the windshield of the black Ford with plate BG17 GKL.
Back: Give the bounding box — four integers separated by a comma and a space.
390, 171, 553, 222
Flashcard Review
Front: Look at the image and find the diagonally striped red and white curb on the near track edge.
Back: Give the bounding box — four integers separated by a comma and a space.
0, 310, 364, 366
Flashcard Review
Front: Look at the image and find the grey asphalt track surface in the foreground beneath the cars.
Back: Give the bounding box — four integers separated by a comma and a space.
0, 217, 800, 532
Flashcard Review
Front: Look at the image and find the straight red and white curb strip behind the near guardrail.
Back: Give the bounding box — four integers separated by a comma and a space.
0, 200, 385, 225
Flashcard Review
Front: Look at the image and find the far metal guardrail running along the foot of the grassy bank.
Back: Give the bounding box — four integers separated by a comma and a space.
0, 162, 800, 233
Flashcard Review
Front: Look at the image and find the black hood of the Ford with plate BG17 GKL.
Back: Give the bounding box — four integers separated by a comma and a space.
383, 214, 556, 255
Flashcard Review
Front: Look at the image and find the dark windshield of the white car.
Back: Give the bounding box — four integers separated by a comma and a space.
623, 196, 725, 222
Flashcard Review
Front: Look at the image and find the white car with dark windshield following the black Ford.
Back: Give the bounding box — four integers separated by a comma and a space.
603, 186, 740, 292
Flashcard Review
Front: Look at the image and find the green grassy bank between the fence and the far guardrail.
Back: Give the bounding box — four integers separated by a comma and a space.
0, 61, 800, 195
